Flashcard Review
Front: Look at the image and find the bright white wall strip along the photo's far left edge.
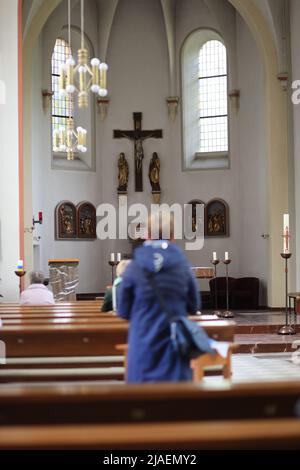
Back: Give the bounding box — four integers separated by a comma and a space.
0, 0, 19, 300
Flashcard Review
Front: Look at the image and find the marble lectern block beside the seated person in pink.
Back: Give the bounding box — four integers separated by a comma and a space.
48, 258, 80, 302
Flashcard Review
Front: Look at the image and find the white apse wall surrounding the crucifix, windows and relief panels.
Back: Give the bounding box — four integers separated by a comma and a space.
32, 0, 268, 302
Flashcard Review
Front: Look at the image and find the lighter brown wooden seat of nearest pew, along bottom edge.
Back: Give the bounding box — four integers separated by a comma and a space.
0, 419, 300, 452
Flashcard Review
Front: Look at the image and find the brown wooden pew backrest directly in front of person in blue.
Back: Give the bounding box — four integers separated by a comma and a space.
0, 320, 235, 357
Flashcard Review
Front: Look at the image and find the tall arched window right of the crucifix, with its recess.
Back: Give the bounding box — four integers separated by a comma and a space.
182, 30, 229, 169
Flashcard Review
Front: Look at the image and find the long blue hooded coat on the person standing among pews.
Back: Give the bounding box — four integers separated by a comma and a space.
118, 241, 200, 383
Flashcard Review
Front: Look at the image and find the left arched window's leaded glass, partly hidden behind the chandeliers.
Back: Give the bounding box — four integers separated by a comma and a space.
51, 38, 74, 151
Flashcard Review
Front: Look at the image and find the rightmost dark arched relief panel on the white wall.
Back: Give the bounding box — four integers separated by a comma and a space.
205, 199, 229, 237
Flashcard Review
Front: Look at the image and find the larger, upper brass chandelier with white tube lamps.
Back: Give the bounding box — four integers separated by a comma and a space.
59, 0, 108, 108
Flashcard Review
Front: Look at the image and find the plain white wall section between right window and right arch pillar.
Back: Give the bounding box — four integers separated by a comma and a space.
234, 12, 269, 305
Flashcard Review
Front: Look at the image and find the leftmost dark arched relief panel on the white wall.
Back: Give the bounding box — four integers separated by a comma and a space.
55, 201, 77, 240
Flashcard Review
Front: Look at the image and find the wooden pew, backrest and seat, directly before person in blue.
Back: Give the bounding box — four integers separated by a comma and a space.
0, 317, 234, 383
